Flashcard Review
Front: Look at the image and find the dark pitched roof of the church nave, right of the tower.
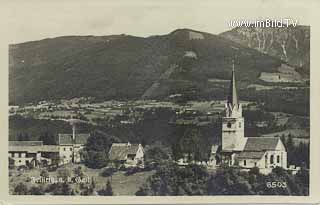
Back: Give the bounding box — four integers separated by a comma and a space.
243, 137, 280, 151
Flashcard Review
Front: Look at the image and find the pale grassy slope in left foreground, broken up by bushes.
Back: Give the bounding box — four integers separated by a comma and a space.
9, 165, 154, 195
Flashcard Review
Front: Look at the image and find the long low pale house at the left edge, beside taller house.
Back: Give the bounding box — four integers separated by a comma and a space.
9, 141, 59, 167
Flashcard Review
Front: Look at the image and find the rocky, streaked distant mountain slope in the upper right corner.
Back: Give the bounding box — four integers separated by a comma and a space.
220, 25, 310, 76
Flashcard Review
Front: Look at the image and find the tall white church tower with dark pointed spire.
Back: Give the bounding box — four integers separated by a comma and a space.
222, 64, 246, 152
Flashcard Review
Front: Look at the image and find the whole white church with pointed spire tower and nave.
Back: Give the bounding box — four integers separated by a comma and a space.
211, 65, 287, 174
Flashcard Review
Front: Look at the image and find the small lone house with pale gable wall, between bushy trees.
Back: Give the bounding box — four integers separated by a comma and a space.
109, 142, 144, 167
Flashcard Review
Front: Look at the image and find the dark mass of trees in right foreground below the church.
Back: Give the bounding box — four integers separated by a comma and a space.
136, 163, 309, 196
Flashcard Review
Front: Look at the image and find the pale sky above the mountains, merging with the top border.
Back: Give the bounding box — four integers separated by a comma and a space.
0, 0, 312, 43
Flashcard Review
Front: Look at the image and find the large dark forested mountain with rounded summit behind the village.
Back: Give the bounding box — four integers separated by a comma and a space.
9, 29, 292, 104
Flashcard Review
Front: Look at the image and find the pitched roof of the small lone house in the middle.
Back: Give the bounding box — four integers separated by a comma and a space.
109, 143, 139, 160
